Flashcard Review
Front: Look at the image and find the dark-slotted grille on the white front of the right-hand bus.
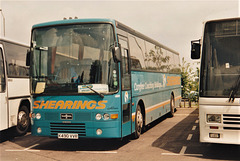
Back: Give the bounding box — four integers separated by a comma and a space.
223, 114, 240, 130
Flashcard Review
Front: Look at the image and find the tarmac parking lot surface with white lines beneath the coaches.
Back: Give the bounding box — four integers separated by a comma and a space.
0, 108, 240, 161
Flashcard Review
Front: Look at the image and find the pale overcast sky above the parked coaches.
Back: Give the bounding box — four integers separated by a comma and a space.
0, 0, 240, 62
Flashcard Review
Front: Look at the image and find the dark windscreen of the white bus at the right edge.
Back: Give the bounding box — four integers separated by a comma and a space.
200, 20, 240, 97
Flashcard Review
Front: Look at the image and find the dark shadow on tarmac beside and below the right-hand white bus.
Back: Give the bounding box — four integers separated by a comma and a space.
152, 109, 240, 161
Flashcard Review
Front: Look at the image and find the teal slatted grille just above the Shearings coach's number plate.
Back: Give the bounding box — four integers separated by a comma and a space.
50, 123, 86, 137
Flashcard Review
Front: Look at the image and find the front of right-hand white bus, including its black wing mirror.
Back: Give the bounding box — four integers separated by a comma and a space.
192, 18, 240, 144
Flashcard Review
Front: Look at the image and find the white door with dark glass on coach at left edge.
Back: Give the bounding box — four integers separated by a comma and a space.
0, 44, 8, 130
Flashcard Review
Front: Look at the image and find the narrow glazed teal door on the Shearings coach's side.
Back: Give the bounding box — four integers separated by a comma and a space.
119, 36, 132, 137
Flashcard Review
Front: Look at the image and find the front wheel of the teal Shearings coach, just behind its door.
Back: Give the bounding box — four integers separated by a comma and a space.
134, 105, 143, 139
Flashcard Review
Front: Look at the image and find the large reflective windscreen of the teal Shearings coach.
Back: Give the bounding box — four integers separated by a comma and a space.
32, 24, 118, 93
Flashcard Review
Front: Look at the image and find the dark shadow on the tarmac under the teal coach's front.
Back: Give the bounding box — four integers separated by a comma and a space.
10, 135, 131, 151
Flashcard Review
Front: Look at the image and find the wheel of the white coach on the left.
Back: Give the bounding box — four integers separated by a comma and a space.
16, 105, 30, 136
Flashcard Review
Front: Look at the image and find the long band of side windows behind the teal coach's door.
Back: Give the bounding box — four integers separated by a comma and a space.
126, 31, 180, 73
